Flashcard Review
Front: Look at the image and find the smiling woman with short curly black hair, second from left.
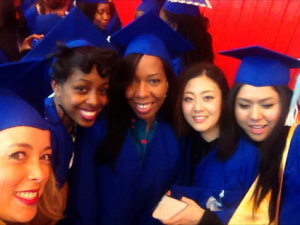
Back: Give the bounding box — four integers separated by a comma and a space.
45, 40, 119, 186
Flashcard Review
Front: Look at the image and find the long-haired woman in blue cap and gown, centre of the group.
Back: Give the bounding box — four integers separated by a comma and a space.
66, 12, 191, 225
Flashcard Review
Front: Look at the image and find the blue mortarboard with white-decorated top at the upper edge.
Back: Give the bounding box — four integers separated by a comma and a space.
163, 0, 211, 16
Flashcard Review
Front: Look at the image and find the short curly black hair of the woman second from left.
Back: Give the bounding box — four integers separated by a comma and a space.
51, 44, 119, 84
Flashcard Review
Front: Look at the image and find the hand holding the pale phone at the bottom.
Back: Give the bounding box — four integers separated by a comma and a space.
161, 197, 205, 225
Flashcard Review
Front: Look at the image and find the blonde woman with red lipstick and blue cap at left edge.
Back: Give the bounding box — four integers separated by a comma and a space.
0, 92, 63, 223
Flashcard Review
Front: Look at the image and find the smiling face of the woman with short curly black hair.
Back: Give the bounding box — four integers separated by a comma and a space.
52, 66, 109, 128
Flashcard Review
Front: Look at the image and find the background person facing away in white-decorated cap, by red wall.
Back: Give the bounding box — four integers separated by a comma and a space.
160, 1, 214, 76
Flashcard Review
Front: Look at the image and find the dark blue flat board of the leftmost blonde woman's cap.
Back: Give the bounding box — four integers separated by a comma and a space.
0, 59, 52, 115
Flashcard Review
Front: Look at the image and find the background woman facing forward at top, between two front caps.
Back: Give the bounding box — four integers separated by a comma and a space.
77, 0, 122, 37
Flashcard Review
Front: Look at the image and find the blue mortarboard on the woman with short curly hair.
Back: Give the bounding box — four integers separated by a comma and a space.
22, 7, 112, 61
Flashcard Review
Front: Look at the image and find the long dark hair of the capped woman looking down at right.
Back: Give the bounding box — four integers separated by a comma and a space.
217, 83, 292, 221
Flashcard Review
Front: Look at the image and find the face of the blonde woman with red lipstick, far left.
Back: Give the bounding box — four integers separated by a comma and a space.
0, 126, 52, 223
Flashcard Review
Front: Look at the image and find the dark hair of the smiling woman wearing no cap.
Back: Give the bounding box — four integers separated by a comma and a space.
174, 62, 229, 136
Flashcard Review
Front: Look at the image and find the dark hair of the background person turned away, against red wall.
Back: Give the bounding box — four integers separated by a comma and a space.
162, 8, 214, 67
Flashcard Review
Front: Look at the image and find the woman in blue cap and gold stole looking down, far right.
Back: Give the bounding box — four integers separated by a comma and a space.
217, 46, 300, 224
